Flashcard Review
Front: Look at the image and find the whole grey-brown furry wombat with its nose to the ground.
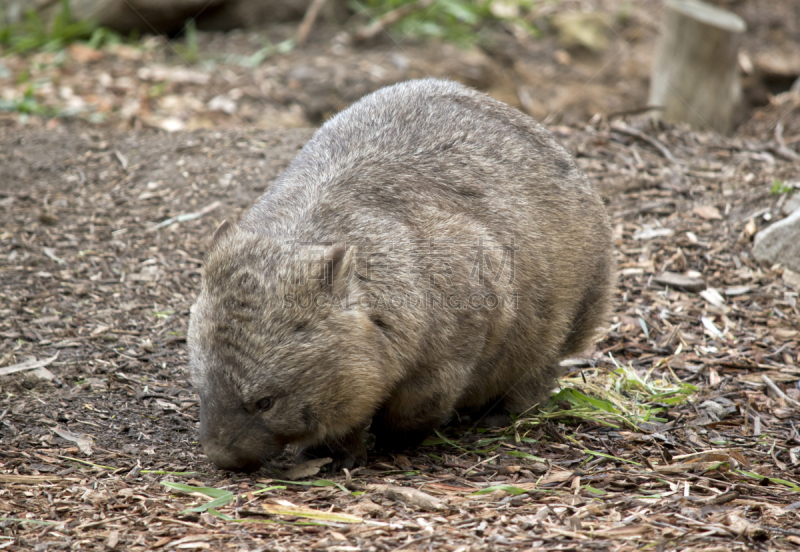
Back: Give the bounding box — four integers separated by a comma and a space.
188, 79, 613, 470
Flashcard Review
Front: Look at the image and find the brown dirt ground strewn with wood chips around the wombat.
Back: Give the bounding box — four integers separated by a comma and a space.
0, 2, 800, 551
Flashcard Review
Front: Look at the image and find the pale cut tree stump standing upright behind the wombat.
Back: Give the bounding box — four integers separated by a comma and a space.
649, 0, 747, 134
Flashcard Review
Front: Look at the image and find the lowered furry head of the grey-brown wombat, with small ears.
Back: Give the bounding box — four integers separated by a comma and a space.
188, 222, 388, 470
